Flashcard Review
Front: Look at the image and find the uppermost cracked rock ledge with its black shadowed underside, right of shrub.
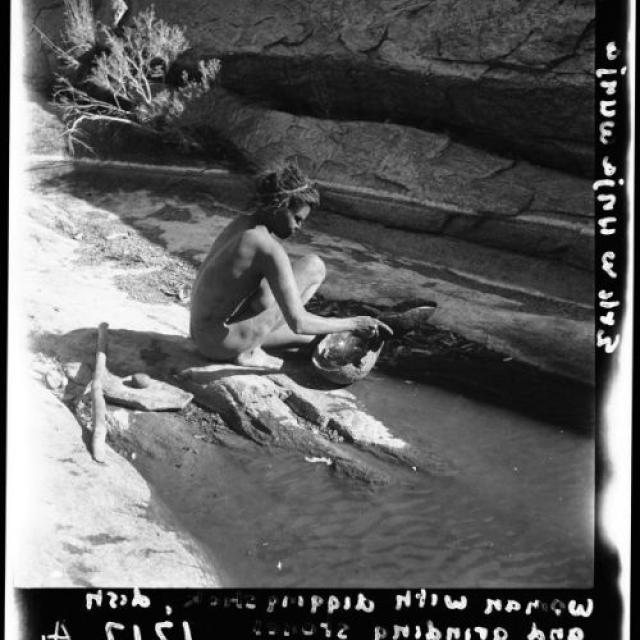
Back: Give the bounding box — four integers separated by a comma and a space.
142, 0, 595, 175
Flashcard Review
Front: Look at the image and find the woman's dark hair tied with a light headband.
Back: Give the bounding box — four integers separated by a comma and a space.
256, 164, 320, 213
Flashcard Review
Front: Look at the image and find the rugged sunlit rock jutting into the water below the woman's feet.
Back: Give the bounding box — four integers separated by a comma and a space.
180, 363, 452, 482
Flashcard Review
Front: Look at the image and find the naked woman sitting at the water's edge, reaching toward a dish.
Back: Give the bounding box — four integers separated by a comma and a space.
191, 165, 391, 369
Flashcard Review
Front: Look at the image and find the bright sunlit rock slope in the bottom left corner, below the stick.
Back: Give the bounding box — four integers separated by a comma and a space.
9, 382, 221, 588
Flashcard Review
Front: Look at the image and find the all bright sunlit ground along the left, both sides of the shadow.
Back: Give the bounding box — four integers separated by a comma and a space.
8, 179, 221, 587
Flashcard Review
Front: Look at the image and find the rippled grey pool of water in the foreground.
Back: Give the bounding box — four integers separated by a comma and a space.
131, 372, 594, 587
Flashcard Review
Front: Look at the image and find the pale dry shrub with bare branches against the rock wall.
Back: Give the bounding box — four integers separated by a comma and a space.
43, 0, 220, 154
